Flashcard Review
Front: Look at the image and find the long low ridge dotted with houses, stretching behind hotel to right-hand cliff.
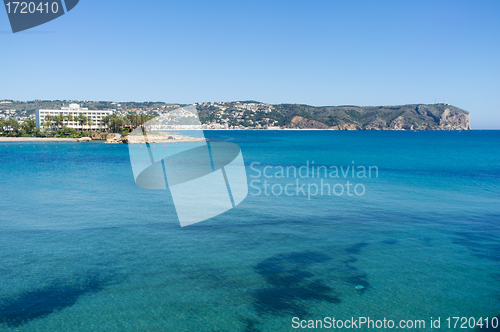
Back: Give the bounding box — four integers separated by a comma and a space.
0, 100, 471, 130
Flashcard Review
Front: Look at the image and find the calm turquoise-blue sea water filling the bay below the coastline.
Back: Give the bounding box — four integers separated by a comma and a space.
0, 131, 500, 331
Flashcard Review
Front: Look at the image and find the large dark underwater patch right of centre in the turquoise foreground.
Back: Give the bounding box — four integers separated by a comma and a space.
249, 242, 370, 324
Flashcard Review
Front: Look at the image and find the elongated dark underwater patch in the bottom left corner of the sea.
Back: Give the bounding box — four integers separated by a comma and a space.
0, 277, 114, 327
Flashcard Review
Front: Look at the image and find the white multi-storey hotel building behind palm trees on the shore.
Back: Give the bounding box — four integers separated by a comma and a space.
36, 104, 113, 131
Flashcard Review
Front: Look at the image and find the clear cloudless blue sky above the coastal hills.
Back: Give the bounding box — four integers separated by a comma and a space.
0, 0, 500, 129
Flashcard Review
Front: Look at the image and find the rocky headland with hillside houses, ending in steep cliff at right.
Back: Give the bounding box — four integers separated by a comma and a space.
197, 101, 471, 130
